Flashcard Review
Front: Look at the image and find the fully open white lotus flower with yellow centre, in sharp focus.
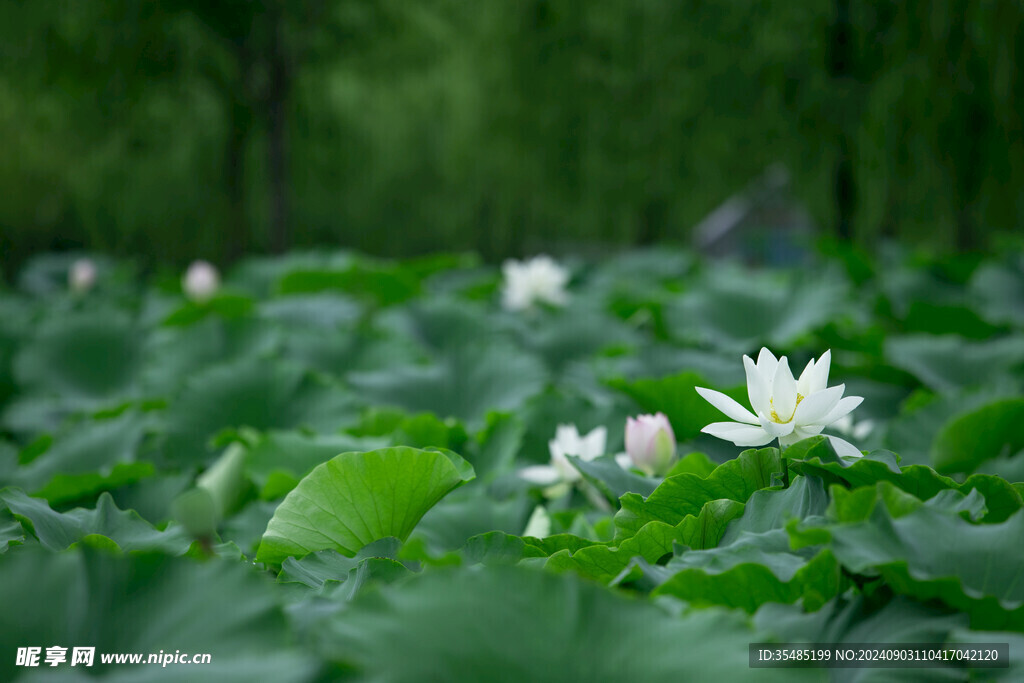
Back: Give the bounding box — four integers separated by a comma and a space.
696, 348, 863, 458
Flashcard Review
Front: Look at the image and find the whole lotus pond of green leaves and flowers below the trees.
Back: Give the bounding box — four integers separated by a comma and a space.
0, 249, 1024, 683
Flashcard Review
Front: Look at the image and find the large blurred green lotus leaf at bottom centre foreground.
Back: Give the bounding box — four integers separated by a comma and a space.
315, 566, 820, 683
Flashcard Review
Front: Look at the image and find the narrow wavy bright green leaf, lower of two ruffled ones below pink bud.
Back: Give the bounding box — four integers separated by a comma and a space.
545, 500, 743, 584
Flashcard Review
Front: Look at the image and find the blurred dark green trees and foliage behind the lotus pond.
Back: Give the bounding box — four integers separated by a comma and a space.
0, 0, 1024, 274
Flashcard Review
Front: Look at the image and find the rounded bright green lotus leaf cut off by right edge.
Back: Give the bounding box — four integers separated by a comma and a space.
932, 398, 1024, 472
